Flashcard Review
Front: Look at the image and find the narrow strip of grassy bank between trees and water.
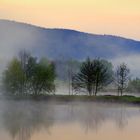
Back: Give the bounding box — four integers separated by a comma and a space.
1, 95, 140, 104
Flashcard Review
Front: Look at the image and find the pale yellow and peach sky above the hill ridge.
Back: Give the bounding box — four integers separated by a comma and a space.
0, 0, 140, 40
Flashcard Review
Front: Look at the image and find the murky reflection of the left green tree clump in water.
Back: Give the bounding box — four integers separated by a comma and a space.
3, 102, 53, 140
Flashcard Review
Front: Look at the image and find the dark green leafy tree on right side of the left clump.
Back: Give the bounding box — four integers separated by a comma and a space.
30, 62, 55, 95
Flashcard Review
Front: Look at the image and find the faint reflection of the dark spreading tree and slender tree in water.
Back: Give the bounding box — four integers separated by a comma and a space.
64, 103, 129, 133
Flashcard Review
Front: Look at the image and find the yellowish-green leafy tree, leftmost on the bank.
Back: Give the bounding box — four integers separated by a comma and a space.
3, 58, 26, 94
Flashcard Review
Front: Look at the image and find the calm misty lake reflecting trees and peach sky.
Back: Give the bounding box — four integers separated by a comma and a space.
0, 101, 140, 140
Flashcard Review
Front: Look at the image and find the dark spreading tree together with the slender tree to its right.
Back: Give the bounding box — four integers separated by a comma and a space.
71, 58, 130, 96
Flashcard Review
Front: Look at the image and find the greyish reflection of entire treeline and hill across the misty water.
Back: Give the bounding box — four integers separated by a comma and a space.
0, 101, 140, 140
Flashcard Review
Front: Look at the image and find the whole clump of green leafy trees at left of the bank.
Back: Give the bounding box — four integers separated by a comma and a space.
3, 52, 56, 95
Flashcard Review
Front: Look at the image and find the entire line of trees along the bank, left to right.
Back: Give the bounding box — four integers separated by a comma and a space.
2, 51, 140, 96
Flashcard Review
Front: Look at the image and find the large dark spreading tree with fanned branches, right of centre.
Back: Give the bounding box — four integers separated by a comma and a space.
72, 58, 113, 96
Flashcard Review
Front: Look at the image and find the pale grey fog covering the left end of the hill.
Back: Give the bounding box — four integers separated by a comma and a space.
0, 21, 38, 72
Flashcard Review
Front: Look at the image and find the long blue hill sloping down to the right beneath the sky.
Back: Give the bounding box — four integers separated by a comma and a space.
0, 20, 140, 59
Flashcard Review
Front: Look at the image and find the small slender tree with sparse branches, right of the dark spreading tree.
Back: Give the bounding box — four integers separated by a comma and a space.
116, 63, 130, 96
